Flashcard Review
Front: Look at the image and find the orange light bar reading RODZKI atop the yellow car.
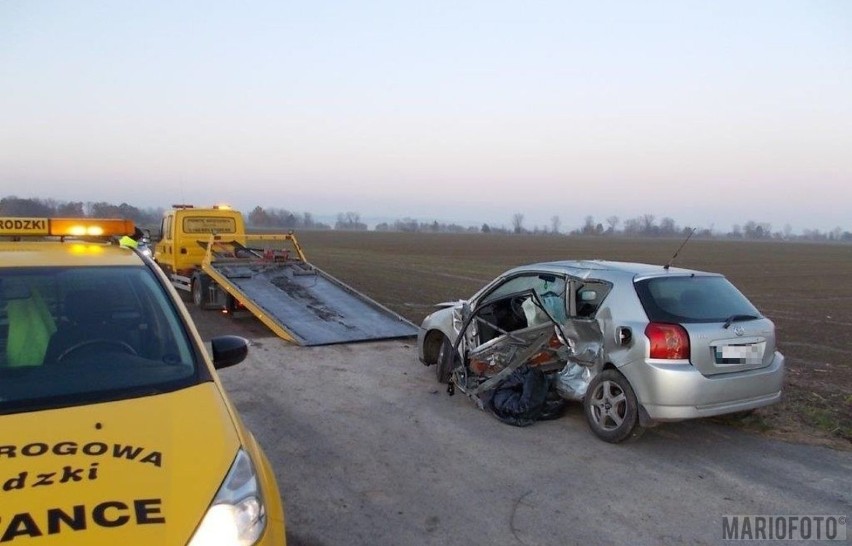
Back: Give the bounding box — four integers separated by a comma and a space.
0, 217, 135, 237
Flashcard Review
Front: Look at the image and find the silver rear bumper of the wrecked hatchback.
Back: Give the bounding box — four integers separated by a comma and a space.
619, 352, 785, 421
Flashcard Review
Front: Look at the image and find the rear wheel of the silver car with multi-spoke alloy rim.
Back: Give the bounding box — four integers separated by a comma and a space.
583, 369, 645, 444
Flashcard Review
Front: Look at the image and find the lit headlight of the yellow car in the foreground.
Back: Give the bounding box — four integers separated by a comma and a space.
189, 449, 266, 546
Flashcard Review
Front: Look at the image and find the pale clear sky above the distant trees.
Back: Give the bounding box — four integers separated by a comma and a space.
0, 0, 852, 231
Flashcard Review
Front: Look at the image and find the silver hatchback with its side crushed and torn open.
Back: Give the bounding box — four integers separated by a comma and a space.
417, 260, 784, 443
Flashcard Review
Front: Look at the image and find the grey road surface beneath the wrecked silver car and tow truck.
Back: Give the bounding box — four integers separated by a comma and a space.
193, 310, 852, 546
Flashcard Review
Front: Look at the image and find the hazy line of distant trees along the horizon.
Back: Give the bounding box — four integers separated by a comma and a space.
0, 196, 852, 243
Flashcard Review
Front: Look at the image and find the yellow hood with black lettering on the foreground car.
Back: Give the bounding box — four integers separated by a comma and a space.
0, 383, 240, 546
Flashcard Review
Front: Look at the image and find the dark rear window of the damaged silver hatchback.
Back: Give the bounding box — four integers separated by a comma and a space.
636, 275, 761, 322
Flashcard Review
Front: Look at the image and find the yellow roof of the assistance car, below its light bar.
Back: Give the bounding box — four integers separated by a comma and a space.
0, 240, 143, 269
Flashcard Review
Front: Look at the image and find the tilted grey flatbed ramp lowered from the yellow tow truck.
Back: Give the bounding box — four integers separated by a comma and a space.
202, 235, 417, 345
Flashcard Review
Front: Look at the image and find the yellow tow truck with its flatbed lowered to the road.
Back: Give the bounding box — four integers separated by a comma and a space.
154, 205, 417, 345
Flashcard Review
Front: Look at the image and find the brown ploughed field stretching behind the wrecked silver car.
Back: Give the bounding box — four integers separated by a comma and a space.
298, 231, 852, 449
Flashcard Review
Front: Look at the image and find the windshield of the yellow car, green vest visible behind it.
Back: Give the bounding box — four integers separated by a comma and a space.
0, 266, 207, 413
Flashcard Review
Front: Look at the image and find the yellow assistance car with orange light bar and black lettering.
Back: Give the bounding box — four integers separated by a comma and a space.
0, 218, 285, 546
